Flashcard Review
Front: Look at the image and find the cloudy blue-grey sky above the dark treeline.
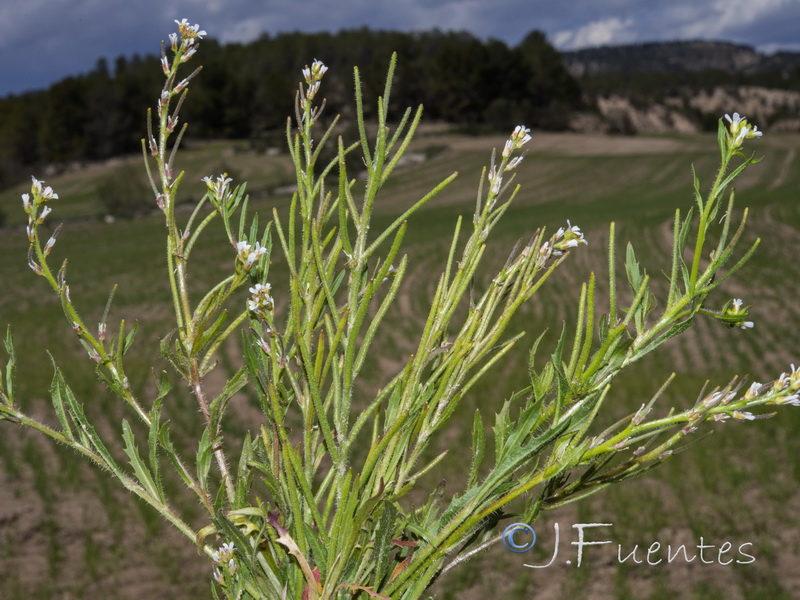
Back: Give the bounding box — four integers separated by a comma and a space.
0, 0, 800, 94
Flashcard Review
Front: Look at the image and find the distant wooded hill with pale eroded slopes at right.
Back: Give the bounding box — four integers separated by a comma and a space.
562, 41, 800, 134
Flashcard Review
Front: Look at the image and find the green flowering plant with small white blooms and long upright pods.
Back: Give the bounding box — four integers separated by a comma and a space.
0, 19, 800, 600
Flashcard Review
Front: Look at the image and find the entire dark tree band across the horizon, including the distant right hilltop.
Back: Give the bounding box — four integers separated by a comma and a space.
0, 28, 800, 216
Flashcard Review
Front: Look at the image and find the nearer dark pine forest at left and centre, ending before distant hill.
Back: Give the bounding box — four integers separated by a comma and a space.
0, 28, 581, 188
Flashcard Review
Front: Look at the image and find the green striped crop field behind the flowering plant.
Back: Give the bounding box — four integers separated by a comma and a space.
0, 130, 800, 600
